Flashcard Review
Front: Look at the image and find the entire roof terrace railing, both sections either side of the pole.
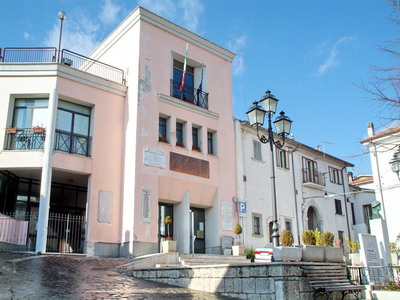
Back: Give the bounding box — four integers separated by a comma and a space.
0, 47, 125, 84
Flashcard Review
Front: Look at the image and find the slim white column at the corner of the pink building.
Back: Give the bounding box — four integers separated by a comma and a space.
35, 89, 58, 254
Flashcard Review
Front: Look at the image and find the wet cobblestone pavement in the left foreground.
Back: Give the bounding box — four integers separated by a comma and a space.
0, 252, 231, 300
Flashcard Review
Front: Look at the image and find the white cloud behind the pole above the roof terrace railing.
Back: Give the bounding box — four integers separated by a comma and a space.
44, 12, 100, 56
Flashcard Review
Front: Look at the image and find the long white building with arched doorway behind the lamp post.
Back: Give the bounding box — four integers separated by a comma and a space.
235, 120, 353, 248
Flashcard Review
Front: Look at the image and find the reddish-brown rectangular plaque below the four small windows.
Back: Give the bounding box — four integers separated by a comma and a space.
169, 152, 210, 178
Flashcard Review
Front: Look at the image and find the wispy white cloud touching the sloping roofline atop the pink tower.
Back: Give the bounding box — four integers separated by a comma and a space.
138, 0, 204, 32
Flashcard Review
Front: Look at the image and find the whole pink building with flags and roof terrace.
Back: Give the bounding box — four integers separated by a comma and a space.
0, 7, 238, 256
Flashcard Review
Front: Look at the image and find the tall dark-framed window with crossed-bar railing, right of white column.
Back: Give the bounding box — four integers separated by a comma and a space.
55, 100, 91, 156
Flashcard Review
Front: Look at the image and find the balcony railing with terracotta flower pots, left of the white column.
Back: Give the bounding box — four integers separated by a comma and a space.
5, 128, 46, 150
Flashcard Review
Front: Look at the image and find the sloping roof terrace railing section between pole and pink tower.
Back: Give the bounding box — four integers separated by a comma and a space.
61, 49, 125, 84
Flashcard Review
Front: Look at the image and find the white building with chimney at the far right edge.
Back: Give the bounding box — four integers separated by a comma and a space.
361, 123, 400, 242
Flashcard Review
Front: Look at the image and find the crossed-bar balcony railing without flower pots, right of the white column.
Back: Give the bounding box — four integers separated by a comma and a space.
54, 129, 92, 157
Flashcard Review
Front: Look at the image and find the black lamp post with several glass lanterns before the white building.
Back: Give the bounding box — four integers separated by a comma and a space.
247, 91, 292, 247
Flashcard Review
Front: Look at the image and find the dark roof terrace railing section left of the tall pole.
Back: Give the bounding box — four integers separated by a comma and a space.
1, 47, 57, 63
